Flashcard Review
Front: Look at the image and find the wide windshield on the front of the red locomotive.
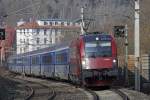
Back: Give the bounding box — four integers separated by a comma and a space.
85, 41, 112, 58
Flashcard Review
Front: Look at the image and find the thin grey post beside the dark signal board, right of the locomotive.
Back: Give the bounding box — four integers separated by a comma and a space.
125, 24, 129, 85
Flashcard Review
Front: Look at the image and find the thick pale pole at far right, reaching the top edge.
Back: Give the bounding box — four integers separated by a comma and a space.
134, 0, 140, 91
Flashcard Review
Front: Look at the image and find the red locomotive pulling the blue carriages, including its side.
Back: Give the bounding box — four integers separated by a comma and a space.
69, 32, 118, 86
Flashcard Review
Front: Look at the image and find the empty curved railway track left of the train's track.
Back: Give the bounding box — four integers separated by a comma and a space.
7, 74, 56, 100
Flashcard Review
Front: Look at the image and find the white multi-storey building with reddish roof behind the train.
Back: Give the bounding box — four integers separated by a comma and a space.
16, 19, 80, 54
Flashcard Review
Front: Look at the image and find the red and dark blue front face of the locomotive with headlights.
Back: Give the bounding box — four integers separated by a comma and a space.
81, 34, 118, 86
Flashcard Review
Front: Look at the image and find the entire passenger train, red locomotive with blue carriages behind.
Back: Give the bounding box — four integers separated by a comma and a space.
8, 32, 118, 86
